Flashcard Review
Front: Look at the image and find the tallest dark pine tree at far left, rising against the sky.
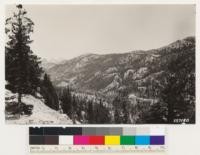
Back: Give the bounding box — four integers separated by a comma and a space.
5, 5, 42, 105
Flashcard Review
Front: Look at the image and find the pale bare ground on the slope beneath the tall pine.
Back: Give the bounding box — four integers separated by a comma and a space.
6, 90, 72, 124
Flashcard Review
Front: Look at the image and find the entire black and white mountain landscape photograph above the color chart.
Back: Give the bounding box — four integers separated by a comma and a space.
5, 4, 196, 125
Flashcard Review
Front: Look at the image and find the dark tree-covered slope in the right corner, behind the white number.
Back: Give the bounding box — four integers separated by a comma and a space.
141, 38, 195, 124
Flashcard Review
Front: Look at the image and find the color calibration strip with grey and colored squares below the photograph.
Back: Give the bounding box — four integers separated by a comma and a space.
29, 127, 166, 153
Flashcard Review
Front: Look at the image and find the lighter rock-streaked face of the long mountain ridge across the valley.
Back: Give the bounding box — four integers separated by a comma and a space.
47, 37, 195, 97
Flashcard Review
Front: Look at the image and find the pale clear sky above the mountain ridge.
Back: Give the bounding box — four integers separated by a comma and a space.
6, 4, 195, 60
